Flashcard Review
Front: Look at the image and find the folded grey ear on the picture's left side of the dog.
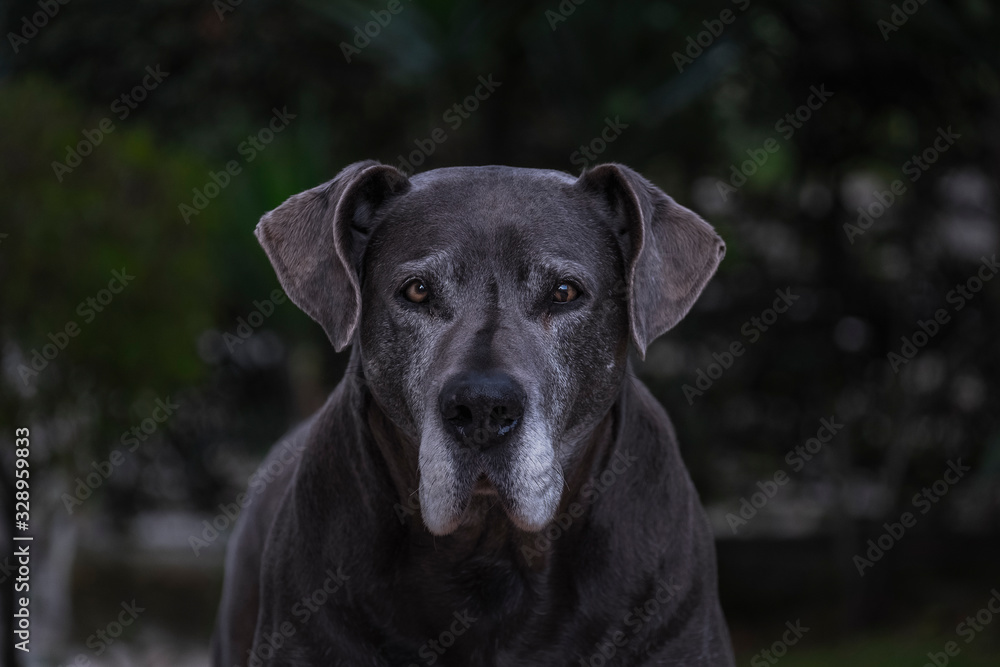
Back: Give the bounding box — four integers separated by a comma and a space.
254, 160, 411, 352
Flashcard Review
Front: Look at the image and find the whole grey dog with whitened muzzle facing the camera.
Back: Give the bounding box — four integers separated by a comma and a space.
213, 161, 734, 667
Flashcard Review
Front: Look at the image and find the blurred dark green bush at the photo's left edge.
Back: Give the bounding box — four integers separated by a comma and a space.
0, 77, 221, 412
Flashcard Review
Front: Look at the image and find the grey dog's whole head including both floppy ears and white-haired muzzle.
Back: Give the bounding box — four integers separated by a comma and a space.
257, 161, 725, 535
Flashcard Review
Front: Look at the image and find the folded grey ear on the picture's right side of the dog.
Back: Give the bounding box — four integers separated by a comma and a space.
576, 164, 726, 358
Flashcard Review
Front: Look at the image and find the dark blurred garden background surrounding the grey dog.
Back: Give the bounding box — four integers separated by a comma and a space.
0, 0, 1000, 667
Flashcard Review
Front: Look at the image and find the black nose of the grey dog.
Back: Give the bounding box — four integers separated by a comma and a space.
440, 371, 525, 447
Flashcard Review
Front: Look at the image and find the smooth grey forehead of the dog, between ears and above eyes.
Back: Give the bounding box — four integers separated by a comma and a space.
376, 167, 612, 273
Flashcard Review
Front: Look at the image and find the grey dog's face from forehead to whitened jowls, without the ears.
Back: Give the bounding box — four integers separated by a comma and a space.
360, 168, 628, 534
